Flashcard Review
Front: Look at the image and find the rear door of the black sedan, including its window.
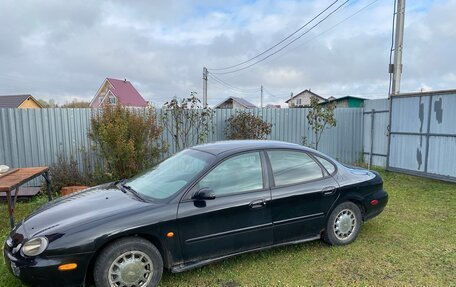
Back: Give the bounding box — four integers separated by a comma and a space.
267, 150, 338, 244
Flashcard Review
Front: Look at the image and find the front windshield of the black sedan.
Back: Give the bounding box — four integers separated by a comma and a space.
127, 149, 215, 200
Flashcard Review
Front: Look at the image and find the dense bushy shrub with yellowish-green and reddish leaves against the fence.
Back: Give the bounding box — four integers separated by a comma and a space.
89, 104, 163, 180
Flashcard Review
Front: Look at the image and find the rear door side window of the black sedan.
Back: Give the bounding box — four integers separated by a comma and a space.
268, 150, 323, 186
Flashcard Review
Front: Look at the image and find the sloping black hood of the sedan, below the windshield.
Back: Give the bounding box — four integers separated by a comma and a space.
22, 184, 154, 238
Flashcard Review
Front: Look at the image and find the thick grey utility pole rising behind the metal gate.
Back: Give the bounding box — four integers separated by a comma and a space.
390, 0, 405, 96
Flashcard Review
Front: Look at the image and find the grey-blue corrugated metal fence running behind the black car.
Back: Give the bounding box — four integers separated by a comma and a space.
0, 108, 363, 187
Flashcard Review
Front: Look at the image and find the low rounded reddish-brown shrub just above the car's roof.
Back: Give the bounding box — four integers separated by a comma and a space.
225, 111, 272, 140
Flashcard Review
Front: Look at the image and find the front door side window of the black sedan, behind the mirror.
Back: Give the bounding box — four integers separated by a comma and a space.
198, 152, 263, 196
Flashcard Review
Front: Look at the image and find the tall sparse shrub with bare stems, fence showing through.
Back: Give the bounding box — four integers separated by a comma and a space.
161, 92, 213, 152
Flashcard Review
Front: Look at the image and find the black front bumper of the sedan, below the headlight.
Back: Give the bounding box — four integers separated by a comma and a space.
3, 244, 92, 286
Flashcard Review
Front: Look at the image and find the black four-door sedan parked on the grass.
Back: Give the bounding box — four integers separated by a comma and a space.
4, 141, 388, 287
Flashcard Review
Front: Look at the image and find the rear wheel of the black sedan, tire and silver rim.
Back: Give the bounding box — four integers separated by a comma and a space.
323, 201, 362, 245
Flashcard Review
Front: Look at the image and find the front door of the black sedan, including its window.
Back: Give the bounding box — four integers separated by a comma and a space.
177, 151, 273, 263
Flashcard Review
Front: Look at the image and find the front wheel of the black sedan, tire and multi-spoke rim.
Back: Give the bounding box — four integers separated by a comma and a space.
93, 237, 163, 287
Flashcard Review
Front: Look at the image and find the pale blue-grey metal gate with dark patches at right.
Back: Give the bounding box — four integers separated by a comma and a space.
387, 90, 456, 182
